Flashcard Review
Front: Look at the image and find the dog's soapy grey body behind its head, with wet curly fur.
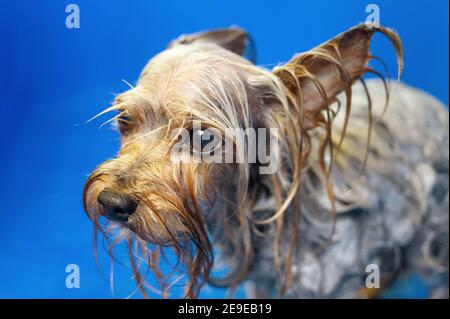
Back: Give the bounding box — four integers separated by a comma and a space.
249, 80, 449, 298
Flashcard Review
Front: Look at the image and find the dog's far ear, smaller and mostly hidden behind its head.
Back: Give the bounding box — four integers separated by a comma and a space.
168, 27, 253, 60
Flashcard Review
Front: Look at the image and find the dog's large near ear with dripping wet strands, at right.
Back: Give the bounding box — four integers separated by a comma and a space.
273, 25, 403, 129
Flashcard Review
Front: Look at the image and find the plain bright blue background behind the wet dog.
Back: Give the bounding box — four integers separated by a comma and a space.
0, 0, 448, 298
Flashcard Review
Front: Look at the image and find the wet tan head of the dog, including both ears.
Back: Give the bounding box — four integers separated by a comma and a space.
83, 26, 402, 297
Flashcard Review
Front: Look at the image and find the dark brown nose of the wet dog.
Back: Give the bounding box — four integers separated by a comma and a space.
97, 190, 137, 221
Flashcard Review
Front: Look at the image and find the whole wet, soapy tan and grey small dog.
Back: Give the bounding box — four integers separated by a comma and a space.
83, 25, 449, 298
